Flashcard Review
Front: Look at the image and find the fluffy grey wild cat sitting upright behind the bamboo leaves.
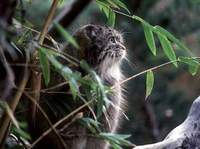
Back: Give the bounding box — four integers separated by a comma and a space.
63, 25, 126, 149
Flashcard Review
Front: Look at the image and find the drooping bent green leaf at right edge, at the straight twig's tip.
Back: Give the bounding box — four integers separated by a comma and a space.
178, 57, 200, 76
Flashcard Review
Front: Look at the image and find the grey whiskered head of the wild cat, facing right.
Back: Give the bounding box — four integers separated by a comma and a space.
75, 24, 126, 67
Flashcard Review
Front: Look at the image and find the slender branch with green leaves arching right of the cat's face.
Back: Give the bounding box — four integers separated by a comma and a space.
96, 0, 200, 98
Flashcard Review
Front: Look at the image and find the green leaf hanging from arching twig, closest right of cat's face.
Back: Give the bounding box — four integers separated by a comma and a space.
142, 23, 156, 55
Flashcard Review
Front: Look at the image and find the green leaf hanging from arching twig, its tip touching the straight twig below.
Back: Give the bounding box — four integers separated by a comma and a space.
157, 34, 178, 67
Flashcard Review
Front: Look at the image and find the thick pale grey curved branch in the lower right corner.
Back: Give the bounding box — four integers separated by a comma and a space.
134, 96, 200, 149
